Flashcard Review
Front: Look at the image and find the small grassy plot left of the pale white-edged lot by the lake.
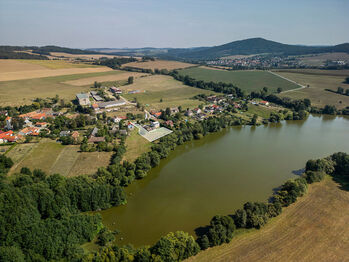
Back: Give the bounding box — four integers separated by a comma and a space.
123, 128, 151, 162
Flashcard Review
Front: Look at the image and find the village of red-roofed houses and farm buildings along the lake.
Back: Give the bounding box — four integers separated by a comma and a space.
0, 81, 269, 148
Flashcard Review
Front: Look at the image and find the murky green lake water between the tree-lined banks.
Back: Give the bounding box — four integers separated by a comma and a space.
99, 116, 349, 247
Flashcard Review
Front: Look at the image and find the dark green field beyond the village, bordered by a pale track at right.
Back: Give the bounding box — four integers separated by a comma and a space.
179, 67, 299, 92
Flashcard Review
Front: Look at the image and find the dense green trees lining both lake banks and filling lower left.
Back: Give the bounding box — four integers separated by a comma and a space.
0, 110, 349, 261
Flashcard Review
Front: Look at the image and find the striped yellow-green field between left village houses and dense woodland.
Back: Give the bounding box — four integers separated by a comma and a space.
7, 139, 112, 176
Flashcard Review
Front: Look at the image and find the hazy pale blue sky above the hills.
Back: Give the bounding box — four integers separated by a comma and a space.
0, 0, 349, 48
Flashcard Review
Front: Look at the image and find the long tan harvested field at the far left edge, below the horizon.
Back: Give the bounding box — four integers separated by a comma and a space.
0, 67, 112, 81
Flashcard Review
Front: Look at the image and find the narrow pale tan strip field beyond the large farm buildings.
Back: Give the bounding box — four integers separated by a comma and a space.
64, 70, 148, 86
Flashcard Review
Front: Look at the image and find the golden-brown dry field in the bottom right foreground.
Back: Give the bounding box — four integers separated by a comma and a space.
187, 178, 349, 262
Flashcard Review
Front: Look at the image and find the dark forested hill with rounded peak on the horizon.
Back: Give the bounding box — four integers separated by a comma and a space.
160, 38, 349, 60
